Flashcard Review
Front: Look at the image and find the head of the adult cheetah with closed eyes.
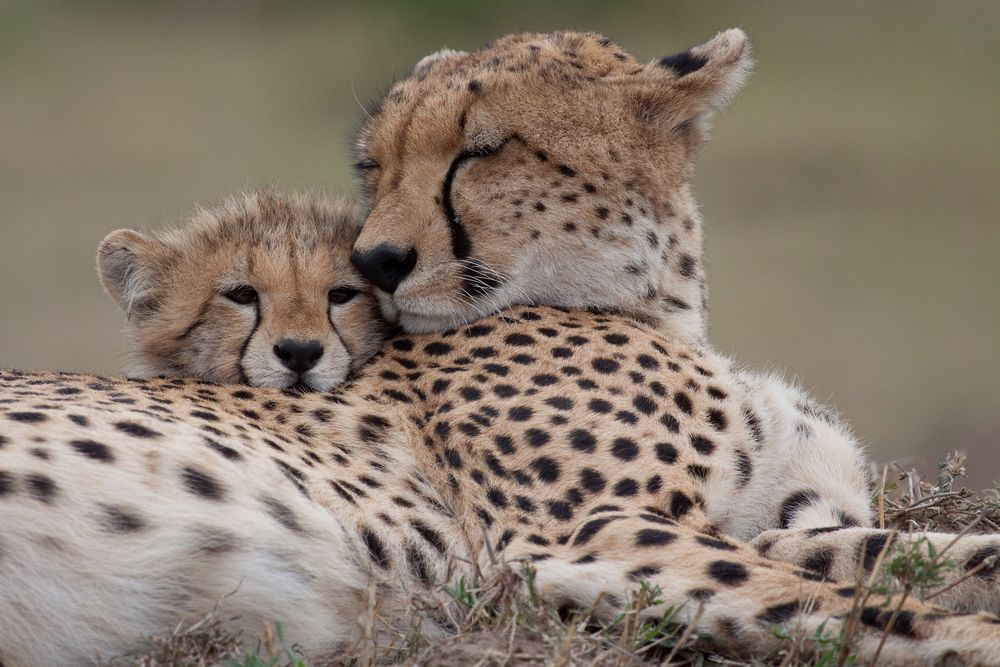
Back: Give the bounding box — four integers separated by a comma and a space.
351, 30, 750, 339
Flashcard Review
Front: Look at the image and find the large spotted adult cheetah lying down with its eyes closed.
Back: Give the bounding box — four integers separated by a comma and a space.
0, 31, 1000, 666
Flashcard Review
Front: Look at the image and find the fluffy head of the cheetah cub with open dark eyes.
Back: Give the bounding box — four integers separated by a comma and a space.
97, 192, 385, 390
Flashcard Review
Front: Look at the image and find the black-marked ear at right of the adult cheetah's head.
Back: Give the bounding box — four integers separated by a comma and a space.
639, 28, 753, 136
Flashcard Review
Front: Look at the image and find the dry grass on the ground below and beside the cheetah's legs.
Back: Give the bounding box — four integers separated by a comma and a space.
125, 454, 1000, 667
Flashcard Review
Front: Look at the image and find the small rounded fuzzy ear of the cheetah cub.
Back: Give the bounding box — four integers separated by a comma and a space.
97, 229, 169, 319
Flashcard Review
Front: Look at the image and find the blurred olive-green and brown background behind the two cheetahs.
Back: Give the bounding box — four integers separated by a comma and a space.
0, 0, 1000, 484
